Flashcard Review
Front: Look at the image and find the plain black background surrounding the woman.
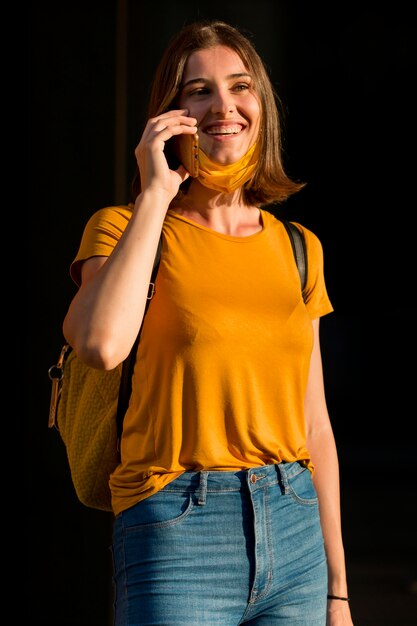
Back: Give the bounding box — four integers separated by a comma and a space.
27, 0, 417, 626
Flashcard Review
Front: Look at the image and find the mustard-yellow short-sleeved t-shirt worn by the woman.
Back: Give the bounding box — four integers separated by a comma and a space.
71, 207, 333, 515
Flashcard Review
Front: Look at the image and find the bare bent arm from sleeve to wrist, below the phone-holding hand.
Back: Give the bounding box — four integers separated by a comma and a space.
63, 188, 169, 369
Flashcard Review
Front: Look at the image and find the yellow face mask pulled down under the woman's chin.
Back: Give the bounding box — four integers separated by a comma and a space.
197, 142, 258, 193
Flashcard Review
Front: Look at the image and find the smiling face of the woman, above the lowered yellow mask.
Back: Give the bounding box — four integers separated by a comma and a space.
178, 45, 261, 165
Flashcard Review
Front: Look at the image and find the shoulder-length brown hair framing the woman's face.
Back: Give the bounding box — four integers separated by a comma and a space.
128, 20, 305, 206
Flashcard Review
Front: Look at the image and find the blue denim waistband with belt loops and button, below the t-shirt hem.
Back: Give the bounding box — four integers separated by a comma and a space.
159, 461, 305, 504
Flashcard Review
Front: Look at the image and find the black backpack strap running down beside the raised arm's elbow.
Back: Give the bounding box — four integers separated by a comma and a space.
116, 234, 162, 444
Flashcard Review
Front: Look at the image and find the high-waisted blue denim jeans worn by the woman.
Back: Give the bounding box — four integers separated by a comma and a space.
112, 462, 327, 626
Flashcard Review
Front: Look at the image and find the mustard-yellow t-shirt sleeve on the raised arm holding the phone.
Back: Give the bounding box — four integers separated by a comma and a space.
70, 206, 132, 287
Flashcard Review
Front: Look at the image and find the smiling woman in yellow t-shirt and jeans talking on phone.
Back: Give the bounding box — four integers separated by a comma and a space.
63, 22, 352, 626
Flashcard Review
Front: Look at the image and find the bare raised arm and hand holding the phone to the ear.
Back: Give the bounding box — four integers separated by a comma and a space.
63, 110, 196, 369
